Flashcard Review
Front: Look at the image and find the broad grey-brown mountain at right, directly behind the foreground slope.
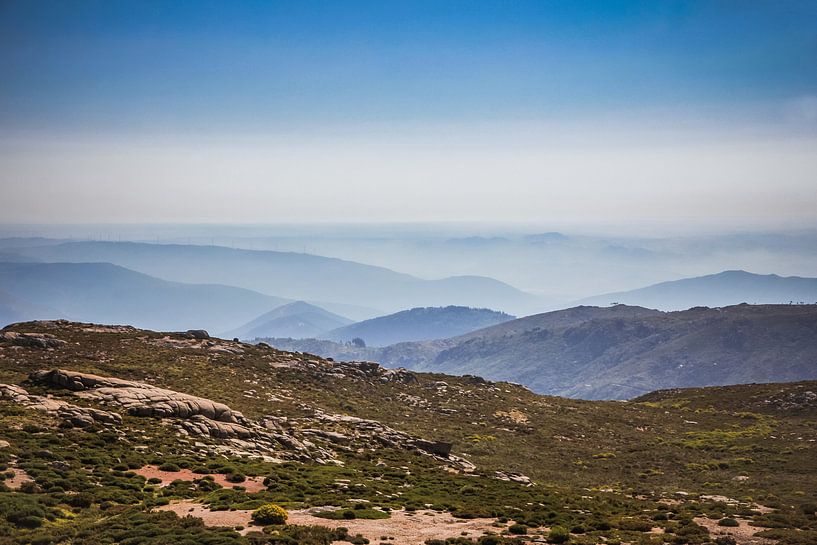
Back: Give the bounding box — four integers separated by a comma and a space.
274, 305, 817, 399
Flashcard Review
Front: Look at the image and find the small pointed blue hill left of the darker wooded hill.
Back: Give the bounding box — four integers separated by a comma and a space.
224, 301, 352, 339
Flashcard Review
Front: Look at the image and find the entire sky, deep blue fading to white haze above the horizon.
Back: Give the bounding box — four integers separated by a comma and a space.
0, 0, 817, 226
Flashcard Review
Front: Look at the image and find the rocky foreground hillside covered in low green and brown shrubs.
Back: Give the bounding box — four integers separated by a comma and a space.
0, 321, 817, 545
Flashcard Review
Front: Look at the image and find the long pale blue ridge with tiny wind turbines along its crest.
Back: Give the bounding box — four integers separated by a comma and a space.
7, 241, 544, 320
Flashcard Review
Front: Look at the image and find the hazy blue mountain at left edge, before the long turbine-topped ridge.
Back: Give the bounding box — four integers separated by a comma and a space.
0, 262, 288, 331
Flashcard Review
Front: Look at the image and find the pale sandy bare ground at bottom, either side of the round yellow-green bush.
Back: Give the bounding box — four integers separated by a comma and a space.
157, 501, 502, 545
